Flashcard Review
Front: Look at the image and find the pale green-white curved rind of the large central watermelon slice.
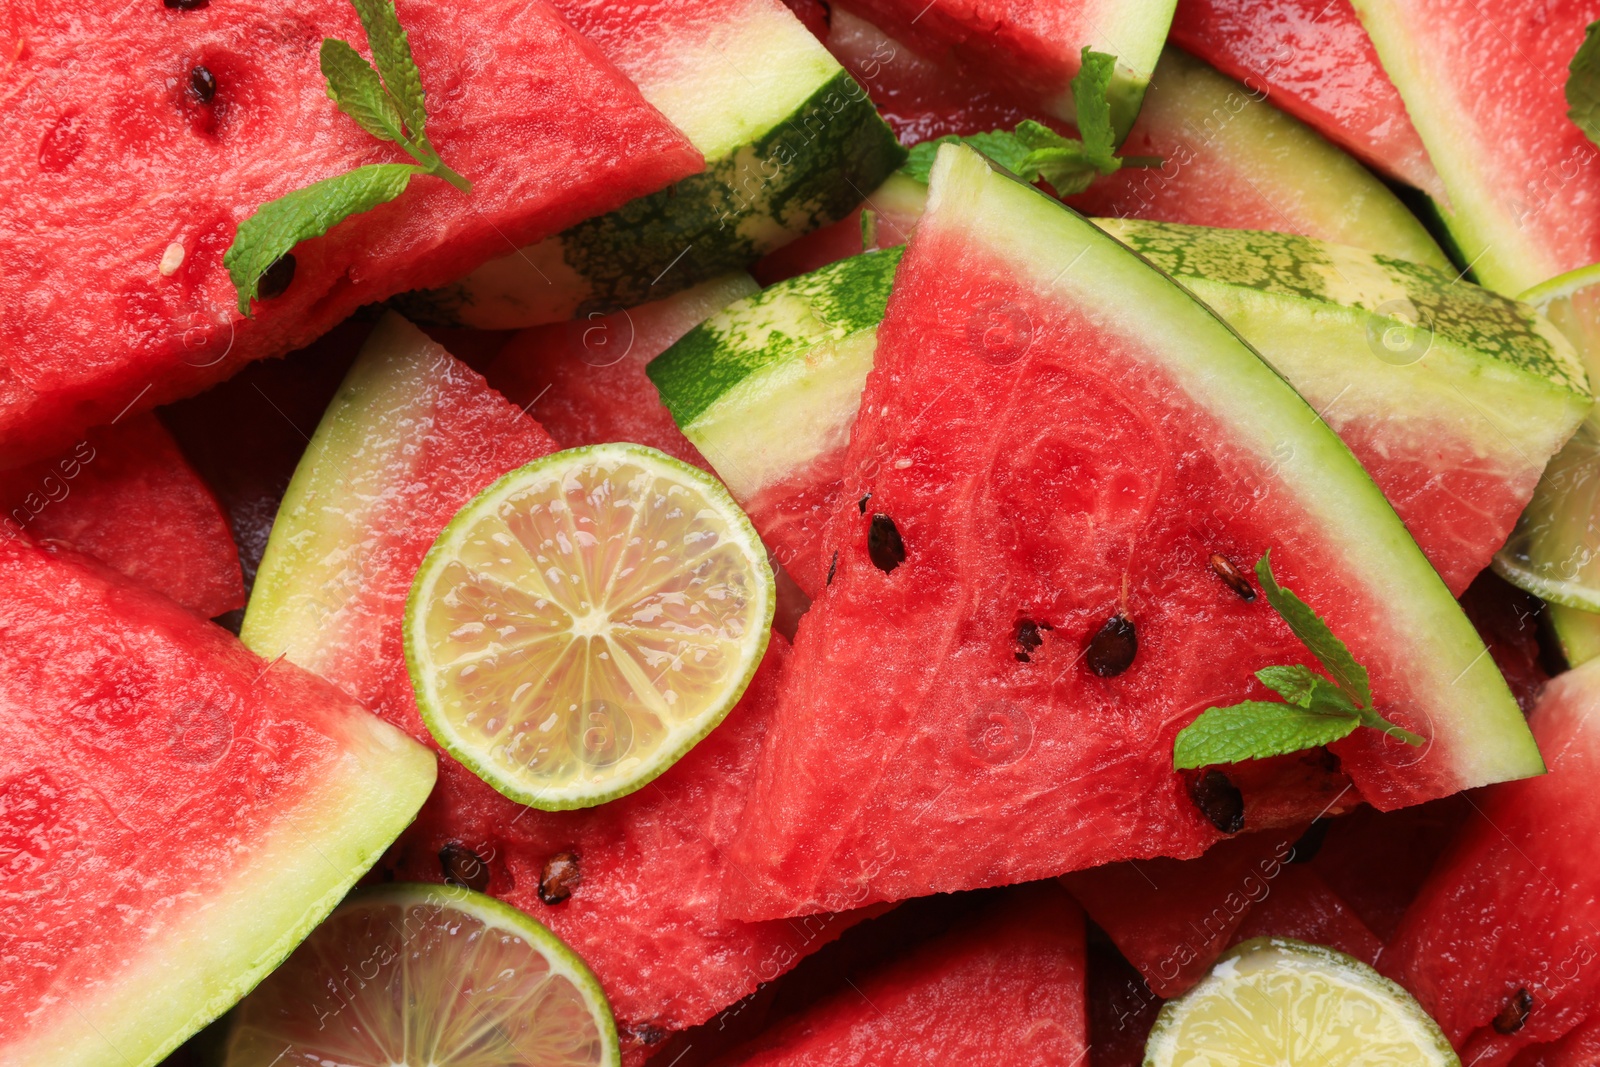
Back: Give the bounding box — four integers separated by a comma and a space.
928, 144, 1544, 789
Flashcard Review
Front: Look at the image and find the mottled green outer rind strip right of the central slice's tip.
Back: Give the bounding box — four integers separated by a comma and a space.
1104, 219, 1589, 394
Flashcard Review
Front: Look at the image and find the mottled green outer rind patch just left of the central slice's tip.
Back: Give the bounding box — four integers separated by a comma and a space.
646, 248, 904, 426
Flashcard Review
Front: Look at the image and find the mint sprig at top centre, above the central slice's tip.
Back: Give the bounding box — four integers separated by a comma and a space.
899, 48, 1162, 197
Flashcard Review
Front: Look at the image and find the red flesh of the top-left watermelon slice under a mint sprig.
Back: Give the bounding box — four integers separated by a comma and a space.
0, 0, 702, 461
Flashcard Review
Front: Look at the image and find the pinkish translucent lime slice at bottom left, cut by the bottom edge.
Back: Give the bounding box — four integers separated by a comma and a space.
224, 883, 622, 1067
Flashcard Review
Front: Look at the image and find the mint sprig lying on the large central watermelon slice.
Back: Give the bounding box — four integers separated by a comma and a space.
1173, 550, 1422, 769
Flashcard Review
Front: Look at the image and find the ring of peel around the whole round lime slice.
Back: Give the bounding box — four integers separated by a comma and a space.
405, 443, 778, 811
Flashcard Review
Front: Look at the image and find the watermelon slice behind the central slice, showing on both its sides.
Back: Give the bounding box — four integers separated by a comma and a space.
650, 223, 1590, 597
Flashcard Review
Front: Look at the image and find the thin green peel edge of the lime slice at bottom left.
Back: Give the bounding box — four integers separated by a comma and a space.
222, 881, 622, 1067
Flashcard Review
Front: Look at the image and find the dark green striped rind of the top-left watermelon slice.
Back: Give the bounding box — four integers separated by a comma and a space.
397, 3, 906, 330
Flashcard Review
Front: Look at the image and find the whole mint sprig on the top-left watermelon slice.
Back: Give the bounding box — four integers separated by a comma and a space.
222, 0, 472, 317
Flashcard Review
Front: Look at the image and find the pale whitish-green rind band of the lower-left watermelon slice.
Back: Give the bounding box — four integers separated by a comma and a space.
15, 704, 435, 1067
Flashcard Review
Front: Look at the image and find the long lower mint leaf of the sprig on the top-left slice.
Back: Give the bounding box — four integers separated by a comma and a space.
222, 163, 426, 315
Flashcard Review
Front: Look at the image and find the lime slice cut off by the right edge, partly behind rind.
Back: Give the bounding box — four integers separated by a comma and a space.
1494, 264, 1600, 611
